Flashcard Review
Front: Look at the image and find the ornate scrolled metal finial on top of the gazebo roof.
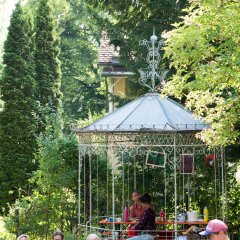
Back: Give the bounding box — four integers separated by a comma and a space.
138, 27, 168, 92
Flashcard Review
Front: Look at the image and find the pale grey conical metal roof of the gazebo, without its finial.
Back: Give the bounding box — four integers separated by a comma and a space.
80, 93, 208, 132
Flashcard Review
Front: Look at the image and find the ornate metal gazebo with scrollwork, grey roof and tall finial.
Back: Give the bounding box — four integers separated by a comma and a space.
75, 31, 226, 238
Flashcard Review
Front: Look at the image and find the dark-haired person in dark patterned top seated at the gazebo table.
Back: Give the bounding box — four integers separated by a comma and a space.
129, 193, 156, 240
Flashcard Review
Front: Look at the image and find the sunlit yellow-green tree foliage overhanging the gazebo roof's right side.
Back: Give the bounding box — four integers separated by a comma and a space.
165, 0, 240, 145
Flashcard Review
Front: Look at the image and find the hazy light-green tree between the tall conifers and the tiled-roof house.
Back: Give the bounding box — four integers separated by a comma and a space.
60, 0, 105, 119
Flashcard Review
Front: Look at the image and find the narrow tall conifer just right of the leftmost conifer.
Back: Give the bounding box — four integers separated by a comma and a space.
35, 0, 62, 125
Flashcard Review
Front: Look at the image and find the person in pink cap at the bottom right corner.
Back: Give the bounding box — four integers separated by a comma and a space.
199, 219, 230, 240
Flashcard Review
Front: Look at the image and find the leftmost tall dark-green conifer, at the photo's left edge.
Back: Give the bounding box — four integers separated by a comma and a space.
0, 4, 37, 210
